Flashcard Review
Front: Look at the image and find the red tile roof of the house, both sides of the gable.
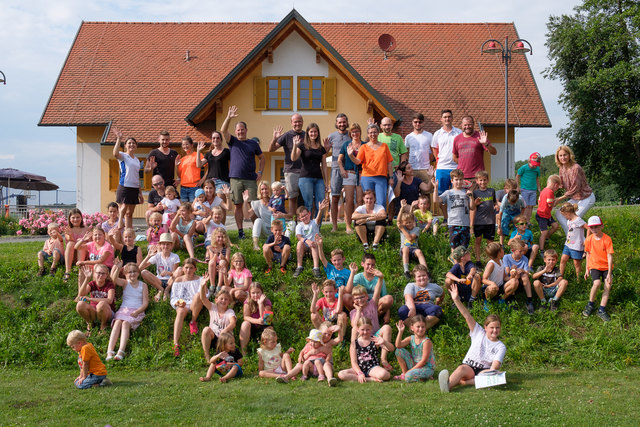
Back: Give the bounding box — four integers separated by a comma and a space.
40, 18, 550, 143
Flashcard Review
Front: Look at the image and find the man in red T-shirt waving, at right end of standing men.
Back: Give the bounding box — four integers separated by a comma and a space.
453, 116, 498, 180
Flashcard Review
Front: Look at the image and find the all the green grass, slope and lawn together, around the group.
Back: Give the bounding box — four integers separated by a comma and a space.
0, 207, 640, 425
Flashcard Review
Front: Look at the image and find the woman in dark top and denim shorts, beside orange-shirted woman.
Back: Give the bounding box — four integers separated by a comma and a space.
338, 123, 366, 234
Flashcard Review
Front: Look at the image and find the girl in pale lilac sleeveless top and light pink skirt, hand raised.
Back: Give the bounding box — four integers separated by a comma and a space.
105, 260, 149, 361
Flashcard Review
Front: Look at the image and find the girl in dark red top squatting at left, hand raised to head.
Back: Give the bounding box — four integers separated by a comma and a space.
76, 264, 116, 335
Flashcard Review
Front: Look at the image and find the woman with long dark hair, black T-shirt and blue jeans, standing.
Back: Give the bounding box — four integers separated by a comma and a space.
291, 123, 328, 217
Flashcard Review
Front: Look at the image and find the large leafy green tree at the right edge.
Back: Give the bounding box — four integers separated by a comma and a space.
545, 0, 640, 201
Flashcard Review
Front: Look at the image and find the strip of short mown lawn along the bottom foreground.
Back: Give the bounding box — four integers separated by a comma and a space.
0, 368, 640, 426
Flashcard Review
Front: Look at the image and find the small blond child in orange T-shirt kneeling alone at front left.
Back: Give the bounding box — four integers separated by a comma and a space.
67, 330, 111, 389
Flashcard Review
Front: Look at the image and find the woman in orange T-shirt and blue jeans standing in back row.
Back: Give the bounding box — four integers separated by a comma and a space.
349, 123, 393, 206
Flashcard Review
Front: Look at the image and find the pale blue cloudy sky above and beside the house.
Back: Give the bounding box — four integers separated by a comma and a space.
0, 0, 579, 203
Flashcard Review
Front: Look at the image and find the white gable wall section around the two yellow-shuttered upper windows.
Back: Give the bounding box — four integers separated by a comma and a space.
262, 31, 329, 116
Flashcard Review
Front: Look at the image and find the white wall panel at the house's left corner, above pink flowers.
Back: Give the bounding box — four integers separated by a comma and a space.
76, 142, 101, 214
